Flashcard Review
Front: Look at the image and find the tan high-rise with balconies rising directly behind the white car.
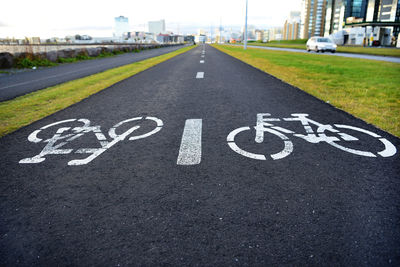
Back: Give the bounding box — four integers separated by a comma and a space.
300, 0, 326, 39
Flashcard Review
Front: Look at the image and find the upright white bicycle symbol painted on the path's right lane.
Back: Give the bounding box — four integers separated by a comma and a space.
227, 113, 397, 160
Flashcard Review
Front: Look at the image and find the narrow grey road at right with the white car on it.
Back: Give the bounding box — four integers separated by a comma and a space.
231, 45, 400, 63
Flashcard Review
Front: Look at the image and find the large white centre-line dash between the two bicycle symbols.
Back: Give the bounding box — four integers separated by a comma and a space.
176, 119, 202, 165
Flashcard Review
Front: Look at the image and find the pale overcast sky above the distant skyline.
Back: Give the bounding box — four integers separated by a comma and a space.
0, 0, 301, 38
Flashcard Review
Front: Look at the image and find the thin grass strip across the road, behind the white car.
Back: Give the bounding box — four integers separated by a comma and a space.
241, 41, 400, 57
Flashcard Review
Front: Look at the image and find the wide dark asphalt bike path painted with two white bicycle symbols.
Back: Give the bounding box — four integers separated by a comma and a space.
0, 46, 400, 266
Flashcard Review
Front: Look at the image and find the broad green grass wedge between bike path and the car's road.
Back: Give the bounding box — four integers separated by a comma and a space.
214, 45, 400, 137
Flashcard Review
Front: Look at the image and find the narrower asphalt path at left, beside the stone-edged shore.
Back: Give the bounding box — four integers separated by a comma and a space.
0, 46, 182, 101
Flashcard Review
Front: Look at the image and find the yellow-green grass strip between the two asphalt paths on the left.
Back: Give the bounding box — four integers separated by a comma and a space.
0, 46, 194, 137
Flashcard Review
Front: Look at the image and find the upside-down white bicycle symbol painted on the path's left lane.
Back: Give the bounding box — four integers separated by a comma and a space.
19, 117, 163, 165
